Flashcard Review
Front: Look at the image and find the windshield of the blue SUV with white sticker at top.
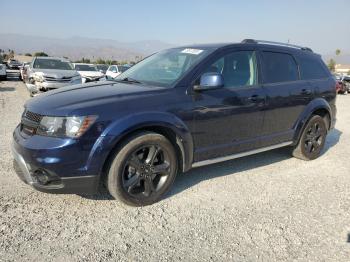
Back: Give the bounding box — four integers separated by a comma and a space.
115, 48, 212, 87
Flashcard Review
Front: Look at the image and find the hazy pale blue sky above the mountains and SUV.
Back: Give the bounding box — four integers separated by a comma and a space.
0, 0, 350, 54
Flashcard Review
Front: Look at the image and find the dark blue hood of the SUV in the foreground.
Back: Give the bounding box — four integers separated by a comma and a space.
25, 81, 166, 116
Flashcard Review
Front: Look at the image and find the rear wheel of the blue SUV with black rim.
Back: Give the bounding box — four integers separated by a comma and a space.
292, 115, 327, 161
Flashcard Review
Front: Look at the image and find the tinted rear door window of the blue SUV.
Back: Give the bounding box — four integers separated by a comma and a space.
263, 52, 299, 83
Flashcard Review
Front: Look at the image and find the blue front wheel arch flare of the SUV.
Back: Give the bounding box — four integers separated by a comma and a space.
91, 112, 193, 171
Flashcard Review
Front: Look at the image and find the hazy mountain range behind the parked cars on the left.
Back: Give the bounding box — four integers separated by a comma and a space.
0, 34, 172, 61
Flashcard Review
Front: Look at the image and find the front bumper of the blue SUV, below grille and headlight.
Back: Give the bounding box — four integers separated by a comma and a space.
12, 127, 100, 194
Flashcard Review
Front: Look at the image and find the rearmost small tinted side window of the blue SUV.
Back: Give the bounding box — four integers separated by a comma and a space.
299, 57, 328, 80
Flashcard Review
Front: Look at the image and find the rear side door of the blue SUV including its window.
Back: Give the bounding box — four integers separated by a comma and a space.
260, 49, 313, 146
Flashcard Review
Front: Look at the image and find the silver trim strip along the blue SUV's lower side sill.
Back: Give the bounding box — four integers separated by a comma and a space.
192, 141, 293, 168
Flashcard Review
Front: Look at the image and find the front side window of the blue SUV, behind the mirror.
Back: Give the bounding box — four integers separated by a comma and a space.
205, 51, 257, 87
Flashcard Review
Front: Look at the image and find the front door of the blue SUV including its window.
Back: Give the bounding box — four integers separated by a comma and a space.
193, 50, 265, 161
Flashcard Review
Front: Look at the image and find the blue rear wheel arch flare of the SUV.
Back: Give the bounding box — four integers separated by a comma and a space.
293, 98, 334, 144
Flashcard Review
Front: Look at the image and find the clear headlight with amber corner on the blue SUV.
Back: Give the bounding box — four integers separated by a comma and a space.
37, 116, 97, 138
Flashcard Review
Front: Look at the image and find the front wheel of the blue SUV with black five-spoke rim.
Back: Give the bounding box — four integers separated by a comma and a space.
106, 132, 178, 206
